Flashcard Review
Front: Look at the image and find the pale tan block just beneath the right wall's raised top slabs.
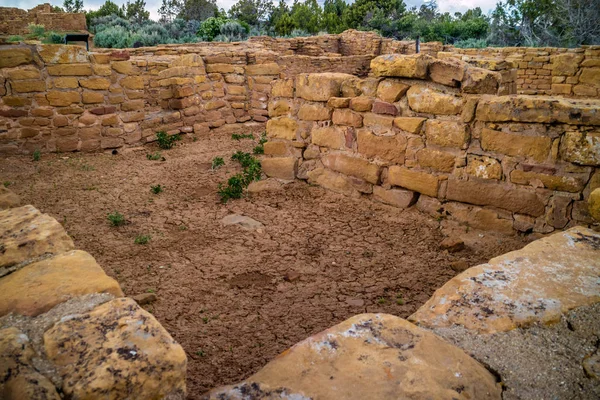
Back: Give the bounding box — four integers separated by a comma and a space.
406, 86, 463, 115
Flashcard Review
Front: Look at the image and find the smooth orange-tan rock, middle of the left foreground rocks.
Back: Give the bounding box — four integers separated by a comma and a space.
0, 250, 123, 317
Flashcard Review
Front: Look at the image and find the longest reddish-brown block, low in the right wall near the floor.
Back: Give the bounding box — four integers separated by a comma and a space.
446, 177, 545, 217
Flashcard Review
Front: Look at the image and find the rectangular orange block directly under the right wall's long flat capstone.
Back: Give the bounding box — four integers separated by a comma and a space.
481, 128, 552, 162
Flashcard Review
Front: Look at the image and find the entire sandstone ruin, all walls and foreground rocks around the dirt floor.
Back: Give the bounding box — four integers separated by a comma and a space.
0, 31, 600, 399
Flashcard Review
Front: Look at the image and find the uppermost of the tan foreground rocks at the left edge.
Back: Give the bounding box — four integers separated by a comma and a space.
0, 206, 74, 276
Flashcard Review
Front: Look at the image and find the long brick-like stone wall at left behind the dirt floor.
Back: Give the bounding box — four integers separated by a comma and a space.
0, 45, 280, 153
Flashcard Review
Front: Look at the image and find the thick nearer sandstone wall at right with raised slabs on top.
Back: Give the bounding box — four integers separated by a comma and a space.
262, 55, 600, 233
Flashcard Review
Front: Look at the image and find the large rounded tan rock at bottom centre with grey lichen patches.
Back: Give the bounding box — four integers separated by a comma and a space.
204, 314, 502, 400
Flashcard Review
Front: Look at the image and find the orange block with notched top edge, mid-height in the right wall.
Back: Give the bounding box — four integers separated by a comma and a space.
357, 129, 408, 164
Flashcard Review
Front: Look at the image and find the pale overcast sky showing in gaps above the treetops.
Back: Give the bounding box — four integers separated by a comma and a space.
0, 0, 497, 20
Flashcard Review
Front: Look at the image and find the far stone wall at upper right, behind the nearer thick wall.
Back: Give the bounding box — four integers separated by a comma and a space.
444, 46, 600, 98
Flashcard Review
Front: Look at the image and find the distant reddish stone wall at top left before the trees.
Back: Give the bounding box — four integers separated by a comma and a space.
0, 3, 87, 35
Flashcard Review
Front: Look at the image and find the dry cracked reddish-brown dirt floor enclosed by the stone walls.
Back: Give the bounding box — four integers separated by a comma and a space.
0, 132, 530, 399
